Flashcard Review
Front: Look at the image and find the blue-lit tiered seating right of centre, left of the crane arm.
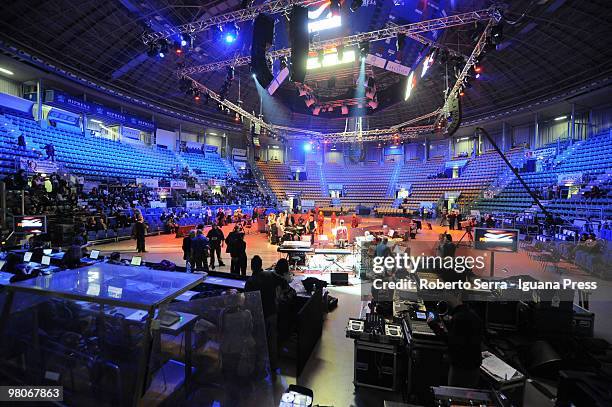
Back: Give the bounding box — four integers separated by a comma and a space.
406, 149, 524, 210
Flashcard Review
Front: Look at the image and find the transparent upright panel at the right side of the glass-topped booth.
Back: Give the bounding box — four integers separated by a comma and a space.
144, 292, 274, 407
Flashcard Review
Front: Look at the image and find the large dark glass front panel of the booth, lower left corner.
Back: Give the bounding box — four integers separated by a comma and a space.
0, 292, 146, 406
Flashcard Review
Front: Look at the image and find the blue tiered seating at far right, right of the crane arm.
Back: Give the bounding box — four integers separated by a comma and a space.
476, 133, 612, 218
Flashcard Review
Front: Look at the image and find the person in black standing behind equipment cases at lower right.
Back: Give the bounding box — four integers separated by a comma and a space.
427, 292, 483, 388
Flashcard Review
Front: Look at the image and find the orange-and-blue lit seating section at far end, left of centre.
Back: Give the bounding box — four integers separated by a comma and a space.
257, 161, 329, 206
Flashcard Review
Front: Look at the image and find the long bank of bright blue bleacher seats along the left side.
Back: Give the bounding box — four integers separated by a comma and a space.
0, 110, 236, 180
